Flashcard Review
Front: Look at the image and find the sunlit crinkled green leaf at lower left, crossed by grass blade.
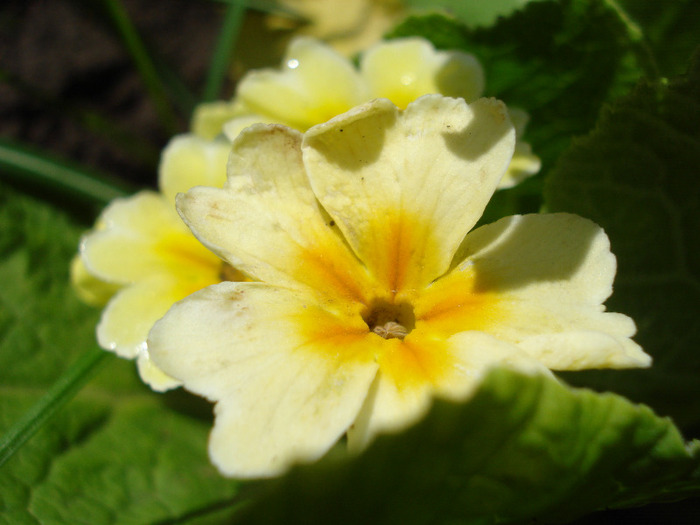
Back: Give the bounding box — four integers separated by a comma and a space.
0, 183, 241, 525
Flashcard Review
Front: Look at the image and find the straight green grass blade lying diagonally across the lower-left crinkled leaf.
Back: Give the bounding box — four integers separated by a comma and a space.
0, 348, 114, 467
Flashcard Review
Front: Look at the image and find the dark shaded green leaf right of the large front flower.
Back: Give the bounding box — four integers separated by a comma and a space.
546, 50, 700, 435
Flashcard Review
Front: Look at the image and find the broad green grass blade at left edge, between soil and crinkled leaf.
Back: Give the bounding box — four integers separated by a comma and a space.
0, 139, 132, 206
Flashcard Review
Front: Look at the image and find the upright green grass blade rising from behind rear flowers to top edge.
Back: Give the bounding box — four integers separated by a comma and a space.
202, 0, 246, 102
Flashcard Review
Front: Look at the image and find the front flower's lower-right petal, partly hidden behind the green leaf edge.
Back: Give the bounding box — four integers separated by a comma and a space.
348, 332, 550, 450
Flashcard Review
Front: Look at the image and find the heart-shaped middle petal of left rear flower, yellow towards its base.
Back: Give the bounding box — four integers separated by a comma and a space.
81, 192, 221, 287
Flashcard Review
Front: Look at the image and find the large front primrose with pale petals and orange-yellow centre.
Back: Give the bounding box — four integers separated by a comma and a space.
149, 95, 650, 477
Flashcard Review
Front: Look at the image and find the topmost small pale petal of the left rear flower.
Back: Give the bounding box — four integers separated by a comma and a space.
158, 134, 231, 206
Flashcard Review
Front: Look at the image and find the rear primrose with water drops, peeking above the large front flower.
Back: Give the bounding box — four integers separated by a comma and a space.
193, 38, 541, 188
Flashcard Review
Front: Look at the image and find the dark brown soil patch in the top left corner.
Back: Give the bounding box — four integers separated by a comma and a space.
0, 0, 230, 185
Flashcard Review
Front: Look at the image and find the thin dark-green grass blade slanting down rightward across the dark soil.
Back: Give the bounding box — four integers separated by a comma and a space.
103, 0, 179, 134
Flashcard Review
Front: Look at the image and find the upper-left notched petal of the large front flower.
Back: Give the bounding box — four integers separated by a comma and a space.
178, 125, 380, 301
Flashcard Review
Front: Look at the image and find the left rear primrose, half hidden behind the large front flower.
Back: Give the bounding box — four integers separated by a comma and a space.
72, 135, 231, 391
